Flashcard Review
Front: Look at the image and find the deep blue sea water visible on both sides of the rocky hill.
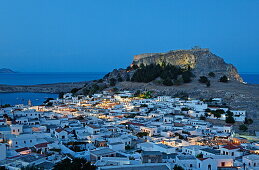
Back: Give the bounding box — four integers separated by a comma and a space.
0, 72, 259, 105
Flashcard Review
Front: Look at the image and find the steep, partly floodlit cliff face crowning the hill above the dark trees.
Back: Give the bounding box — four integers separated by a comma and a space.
133, 49, 243, 82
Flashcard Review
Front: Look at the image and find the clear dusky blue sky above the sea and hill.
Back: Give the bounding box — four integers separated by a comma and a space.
0, 0, 259, 72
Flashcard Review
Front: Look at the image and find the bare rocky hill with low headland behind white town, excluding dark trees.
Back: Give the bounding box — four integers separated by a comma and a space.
0, 49, 259, 133
